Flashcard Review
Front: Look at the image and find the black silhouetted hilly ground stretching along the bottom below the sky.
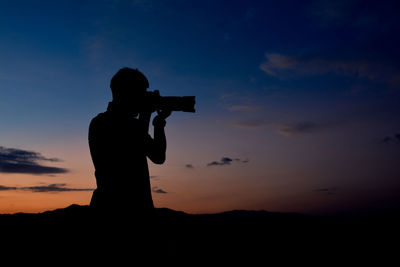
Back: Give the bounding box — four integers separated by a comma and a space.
0, 205, 399, 265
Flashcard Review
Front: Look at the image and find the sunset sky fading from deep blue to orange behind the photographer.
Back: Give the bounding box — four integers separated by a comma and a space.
0, 0, 400, 214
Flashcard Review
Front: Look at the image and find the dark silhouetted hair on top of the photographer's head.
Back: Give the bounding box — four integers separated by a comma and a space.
110, 68, 149, 96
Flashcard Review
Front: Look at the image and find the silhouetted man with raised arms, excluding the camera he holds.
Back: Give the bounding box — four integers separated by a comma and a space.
89, 68, 171, 215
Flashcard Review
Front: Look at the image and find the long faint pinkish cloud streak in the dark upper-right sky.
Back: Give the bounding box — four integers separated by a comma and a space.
260, 53, 400, 86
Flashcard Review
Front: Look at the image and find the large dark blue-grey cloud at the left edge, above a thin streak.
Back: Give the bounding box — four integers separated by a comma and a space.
0, 146, 68, 175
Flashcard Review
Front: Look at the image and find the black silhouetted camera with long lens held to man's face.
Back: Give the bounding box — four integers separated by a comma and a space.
141, 90, 196, 113
